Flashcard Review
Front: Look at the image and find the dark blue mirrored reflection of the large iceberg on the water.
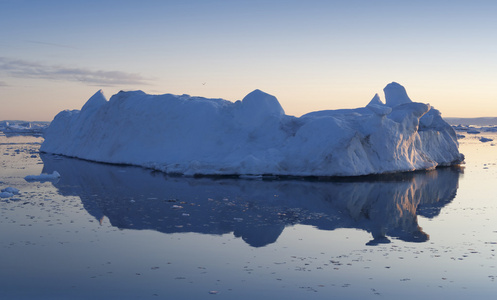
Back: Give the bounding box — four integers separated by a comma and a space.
42, 155, 461, 247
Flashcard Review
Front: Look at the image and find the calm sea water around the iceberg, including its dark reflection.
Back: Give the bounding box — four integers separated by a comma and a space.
0, 133, 497, 299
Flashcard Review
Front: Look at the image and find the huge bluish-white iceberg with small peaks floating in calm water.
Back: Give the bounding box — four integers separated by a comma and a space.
41, 83, 464, 176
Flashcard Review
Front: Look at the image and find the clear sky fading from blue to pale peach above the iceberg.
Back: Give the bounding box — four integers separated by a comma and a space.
0, 0, 497, 121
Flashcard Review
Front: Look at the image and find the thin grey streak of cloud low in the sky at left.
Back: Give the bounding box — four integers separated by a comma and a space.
0, 57, 148, 86
